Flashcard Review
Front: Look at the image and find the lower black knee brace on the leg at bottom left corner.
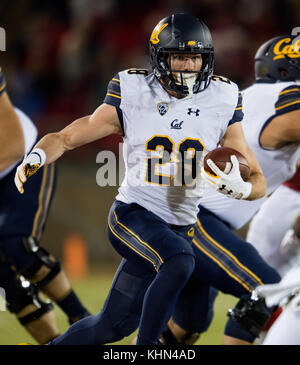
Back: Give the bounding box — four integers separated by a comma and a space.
6, 275, 53, 326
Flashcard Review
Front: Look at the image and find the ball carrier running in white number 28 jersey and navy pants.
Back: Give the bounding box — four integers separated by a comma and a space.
15, 14, 265, 345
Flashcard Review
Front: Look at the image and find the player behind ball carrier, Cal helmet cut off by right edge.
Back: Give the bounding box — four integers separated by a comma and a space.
162, 36, 300, 344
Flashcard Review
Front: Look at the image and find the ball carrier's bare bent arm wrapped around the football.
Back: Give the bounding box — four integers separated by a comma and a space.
220, 122, 266, 200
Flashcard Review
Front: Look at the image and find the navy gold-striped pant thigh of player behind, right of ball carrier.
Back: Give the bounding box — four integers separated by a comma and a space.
193, 207, 280, 298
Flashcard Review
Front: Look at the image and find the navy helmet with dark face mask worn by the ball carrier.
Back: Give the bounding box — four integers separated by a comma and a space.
149, 14, 214, 97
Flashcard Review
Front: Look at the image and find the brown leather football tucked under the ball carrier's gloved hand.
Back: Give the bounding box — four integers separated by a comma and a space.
204, 147, 250, 181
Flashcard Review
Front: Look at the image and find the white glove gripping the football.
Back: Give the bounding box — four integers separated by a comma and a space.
201, 155, 252, 199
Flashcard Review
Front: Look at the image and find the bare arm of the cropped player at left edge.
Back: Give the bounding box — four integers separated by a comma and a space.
0, 91, 25, 171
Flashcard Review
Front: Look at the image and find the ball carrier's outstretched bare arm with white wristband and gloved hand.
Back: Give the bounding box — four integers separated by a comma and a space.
15, 104, 123, 193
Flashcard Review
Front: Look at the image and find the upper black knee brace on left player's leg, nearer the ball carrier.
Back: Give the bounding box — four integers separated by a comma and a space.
22, 237, 61, 288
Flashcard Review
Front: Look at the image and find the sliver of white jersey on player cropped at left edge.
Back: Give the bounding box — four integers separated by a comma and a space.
0, 108, 38, 179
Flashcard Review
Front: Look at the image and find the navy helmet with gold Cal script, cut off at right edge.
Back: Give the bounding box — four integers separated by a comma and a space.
254, 35, 300, 83
